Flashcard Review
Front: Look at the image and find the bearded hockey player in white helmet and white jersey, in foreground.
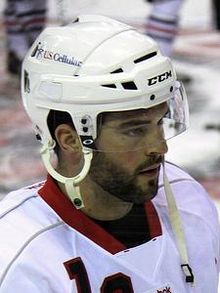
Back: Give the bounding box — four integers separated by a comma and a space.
0, 15, 220, 293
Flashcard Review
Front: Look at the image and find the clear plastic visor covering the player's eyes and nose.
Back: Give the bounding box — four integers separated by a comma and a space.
83, 84, 189, 152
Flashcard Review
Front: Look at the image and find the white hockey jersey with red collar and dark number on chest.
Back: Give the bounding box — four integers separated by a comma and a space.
0, 164, 220, 293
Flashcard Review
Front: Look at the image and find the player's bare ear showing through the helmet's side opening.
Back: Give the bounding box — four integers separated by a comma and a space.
55, 124, 82, 153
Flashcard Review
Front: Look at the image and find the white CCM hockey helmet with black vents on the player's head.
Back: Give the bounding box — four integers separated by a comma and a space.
22, 15, 187, 152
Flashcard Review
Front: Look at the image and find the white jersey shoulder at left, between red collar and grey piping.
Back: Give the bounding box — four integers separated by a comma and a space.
0, 182, 61, 279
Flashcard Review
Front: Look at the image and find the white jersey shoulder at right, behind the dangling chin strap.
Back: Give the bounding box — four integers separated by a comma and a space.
155, 163, 219, 234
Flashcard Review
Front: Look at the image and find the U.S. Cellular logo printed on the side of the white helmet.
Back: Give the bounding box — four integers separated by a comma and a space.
31, 42, 82, 67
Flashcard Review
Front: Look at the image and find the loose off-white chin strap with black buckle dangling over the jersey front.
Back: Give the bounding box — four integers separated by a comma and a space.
163, 161, 194, 285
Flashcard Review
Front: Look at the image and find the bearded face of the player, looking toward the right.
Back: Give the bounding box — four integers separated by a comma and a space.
89, 103, 167, 203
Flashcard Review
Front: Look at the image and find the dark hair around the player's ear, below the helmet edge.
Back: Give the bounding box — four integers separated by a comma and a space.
47, 110, 75, 155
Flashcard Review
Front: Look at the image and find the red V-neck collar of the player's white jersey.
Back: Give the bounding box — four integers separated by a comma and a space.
38, 176, 162, 254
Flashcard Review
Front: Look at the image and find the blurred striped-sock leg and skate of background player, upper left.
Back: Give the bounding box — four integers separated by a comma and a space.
4, 0, 47, 76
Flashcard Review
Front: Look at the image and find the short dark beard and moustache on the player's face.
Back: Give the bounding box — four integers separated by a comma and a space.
89, 152, 162, 204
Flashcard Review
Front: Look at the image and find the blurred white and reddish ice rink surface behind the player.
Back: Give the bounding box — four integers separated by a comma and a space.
0, 0, 220, 211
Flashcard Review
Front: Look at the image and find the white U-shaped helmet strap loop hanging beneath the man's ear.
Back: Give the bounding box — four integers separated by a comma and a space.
40, 140, 93, 209
